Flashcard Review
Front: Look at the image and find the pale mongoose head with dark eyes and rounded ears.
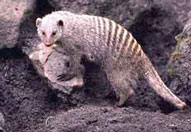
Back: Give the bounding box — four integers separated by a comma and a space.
36, 15, 64, 46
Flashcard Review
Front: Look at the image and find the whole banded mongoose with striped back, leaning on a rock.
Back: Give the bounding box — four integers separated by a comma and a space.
36, 11, 186, 109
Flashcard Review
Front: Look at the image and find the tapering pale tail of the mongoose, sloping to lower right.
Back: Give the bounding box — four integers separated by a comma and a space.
143, 54, 186, 109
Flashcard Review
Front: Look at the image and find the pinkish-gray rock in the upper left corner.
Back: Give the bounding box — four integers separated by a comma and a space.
0, 0, 34, 49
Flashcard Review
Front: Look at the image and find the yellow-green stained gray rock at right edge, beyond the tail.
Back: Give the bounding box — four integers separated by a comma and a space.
167, 19, 191, 104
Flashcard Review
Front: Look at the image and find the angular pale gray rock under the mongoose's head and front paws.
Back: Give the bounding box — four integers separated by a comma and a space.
29, 43, 85, 94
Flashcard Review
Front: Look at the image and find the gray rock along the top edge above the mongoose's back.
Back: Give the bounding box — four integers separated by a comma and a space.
48, 0, 191, 28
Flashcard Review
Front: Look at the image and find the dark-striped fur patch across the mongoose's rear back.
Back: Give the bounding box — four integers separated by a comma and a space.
92, 16, 142, 59
